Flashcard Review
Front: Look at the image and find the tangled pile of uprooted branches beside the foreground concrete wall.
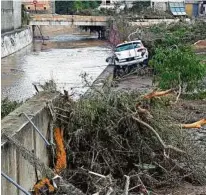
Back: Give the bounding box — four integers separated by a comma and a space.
55, 92, 206, 194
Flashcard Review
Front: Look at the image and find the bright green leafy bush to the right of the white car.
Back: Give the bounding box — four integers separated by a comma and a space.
150, 45, 206, 91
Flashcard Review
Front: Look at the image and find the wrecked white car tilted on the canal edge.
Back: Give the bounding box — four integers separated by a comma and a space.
106, 40, 148, 67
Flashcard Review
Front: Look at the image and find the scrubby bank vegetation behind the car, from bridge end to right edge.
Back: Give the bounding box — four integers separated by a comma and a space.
109, 15, 206, 53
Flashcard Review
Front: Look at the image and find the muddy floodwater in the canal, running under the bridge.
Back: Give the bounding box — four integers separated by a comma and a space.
1, 35, 109, 101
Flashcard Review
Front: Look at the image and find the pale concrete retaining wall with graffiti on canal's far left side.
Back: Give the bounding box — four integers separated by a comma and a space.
1, 27, 33, 58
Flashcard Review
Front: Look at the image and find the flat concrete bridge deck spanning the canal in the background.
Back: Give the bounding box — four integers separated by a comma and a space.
29, 14, 110, 26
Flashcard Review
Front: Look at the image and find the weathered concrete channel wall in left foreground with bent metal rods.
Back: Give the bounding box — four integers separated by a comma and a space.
1, 92, 59, 195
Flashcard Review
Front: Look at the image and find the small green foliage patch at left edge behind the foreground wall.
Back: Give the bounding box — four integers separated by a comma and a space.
1, 98, 22, 118
